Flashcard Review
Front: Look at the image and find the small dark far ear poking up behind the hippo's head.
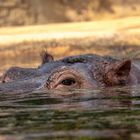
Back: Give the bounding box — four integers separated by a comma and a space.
41, 50, 54, 65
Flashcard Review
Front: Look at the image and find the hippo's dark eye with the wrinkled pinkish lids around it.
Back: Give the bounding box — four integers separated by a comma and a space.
46, 69, 83, 91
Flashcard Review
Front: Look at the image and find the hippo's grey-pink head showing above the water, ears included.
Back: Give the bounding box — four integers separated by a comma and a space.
0, 52, 140, 90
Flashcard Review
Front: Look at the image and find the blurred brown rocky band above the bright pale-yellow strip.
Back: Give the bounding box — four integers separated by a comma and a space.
0, 0, 140, 26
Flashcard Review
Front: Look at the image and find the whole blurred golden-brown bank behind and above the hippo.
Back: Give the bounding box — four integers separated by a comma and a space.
0, 0, 140, 72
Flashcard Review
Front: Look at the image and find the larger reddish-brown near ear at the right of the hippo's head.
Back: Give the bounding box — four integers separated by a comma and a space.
105, 60, 131, 85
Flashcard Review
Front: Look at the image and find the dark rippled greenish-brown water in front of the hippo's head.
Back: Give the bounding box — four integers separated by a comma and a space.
0, 86, 140, 140
